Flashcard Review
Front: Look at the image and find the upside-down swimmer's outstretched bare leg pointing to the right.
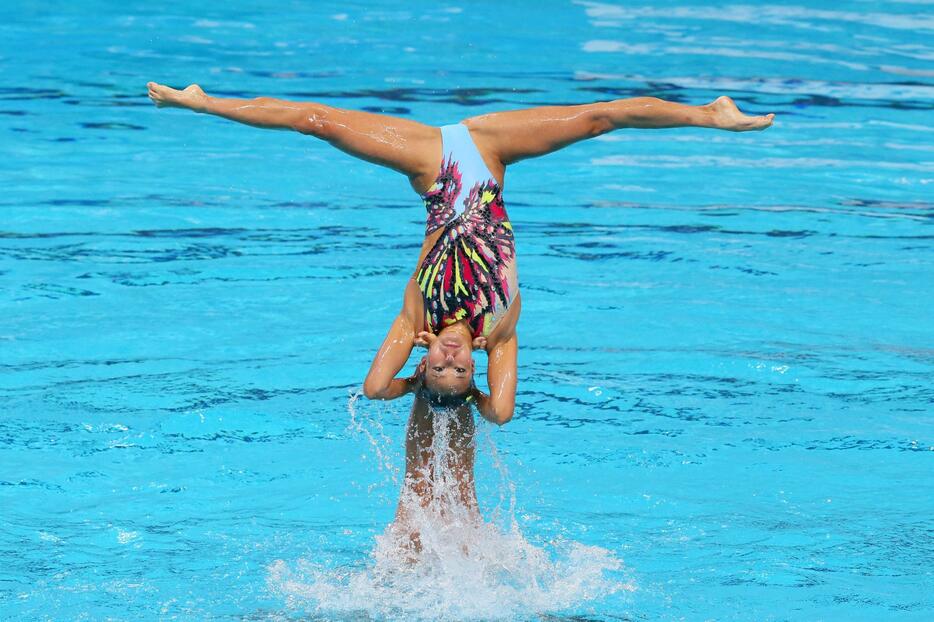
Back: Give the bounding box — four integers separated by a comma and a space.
464, 96, 775, 166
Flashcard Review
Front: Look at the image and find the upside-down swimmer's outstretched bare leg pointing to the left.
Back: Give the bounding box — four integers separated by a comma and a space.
147, 82, 441, 193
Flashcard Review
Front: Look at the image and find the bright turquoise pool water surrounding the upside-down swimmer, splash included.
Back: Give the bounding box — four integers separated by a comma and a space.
0, 0, 934, 620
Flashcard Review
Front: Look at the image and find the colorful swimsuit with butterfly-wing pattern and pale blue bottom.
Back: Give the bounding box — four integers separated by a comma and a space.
415, 123, 519, 337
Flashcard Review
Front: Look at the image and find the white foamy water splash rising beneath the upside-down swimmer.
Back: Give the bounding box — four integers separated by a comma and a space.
268, 396, 633, 620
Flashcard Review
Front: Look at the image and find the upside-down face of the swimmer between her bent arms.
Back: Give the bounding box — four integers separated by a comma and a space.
415, 323, 486, 397
